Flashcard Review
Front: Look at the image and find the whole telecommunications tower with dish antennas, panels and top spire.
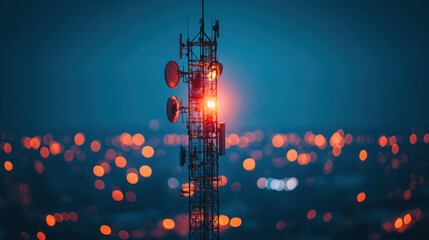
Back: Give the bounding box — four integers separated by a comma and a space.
165, 0, 225, 240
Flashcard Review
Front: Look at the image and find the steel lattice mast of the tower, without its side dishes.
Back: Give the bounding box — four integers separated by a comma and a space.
182, 15, 220, 240
